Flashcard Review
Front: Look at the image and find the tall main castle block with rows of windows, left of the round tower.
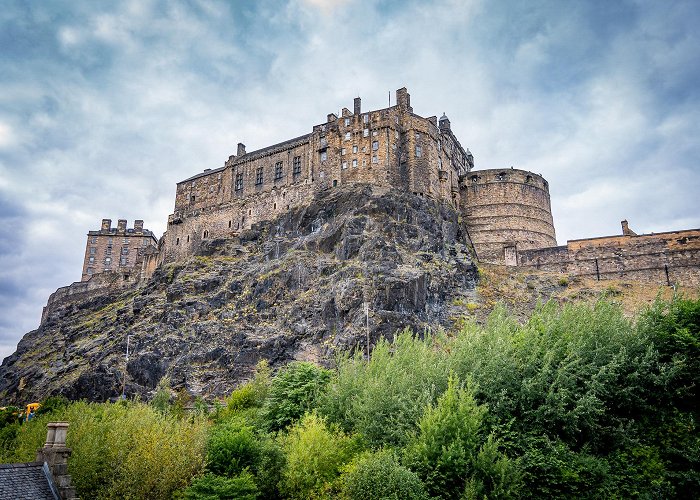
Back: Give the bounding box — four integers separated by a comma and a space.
161, 89, 473, 262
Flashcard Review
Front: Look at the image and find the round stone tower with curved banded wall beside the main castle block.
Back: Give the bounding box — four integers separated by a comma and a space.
461, 168, 557, 266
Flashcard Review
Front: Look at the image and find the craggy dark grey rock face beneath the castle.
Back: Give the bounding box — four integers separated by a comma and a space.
0, 185, 477, 402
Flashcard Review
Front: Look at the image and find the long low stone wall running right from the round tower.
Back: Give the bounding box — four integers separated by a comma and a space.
518, 229, 700, 287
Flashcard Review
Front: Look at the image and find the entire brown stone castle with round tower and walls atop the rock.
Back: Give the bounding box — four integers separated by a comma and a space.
64, 88, 700, 310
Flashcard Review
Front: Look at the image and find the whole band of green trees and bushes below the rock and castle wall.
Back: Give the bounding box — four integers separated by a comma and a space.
1, 299, 700, 500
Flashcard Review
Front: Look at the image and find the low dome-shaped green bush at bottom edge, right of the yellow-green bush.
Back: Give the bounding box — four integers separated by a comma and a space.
342, 451, 428, 500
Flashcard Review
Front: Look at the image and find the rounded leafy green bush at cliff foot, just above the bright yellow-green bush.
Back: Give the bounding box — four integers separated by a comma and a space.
262, 362, 331, 431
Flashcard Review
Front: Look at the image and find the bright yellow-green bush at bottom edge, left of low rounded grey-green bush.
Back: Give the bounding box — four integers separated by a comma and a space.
280, 414, 361, 499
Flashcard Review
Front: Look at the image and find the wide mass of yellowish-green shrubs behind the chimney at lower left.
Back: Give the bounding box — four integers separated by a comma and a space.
3, 401, 208, 499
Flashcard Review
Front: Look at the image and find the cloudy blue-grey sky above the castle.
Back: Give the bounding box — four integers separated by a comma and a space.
0, 0, 700, 358
